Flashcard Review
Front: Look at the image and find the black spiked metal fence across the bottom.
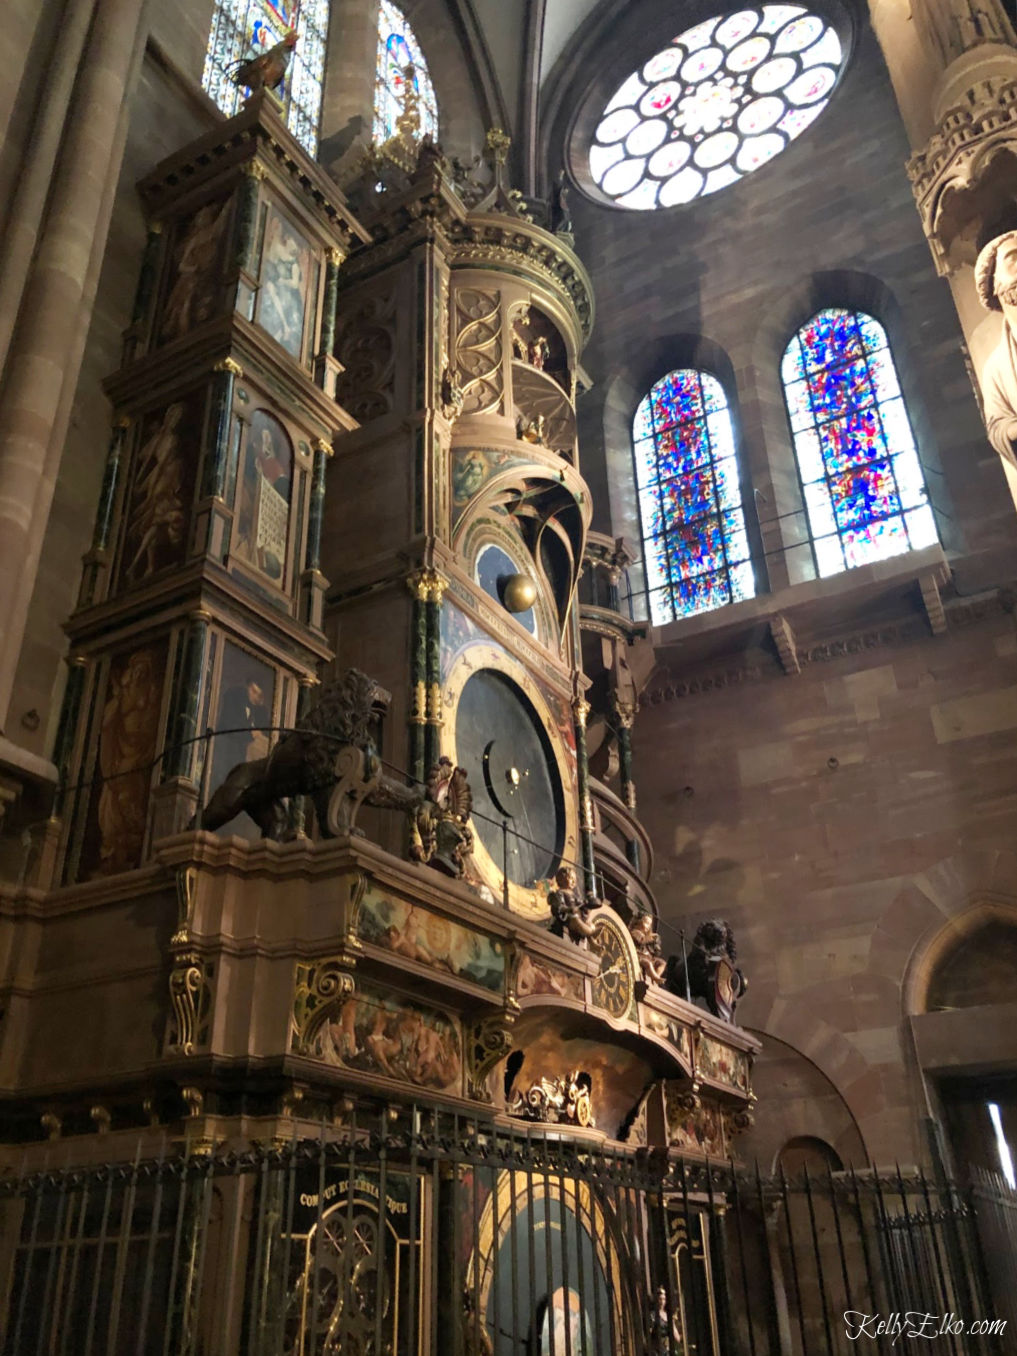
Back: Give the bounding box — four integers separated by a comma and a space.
0, 1108, 1017, 1356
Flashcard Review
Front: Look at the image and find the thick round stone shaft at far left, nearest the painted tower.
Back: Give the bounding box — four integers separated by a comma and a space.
0, 0, 151, 727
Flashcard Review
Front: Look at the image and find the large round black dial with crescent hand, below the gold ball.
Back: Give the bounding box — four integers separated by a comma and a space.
456, 670, 565, 885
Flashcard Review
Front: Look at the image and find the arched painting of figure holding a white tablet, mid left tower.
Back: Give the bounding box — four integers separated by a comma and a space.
232, 410, 293, 589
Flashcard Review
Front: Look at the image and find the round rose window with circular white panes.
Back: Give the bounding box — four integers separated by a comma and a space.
590, 4, 843, 212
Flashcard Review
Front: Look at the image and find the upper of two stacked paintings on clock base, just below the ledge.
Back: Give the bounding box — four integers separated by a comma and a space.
358, 887, 504, 994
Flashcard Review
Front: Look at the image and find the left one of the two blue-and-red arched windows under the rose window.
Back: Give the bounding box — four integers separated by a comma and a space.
632, 367, 755, 625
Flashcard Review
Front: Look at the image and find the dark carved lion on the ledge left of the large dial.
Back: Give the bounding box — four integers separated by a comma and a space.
199, 669, 422, 838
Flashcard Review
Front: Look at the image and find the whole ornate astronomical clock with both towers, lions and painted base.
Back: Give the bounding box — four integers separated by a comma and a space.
11, 95, 757, 1356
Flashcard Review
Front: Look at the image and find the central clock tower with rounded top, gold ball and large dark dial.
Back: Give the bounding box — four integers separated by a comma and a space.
323, 136, 593, 919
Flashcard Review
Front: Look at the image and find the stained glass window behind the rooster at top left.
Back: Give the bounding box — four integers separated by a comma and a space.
201, 0, 330, 156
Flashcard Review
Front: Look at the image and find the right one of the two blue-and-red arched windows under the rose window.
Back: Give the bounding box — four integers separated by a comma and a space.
781, 309, 938, 575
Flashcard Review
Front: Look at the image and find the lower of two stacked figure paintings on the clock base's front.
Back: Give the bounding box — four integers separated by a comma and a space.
311, 987, 462, 1092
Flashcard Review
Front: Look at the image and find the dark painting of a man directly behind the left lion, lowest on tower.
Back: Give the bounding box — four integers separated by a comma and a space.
209, 641, 275, 837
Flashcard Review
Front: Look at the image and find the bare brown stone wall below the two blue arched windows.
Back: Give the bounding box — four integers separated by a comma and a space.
635, 602, 1017, 1162
